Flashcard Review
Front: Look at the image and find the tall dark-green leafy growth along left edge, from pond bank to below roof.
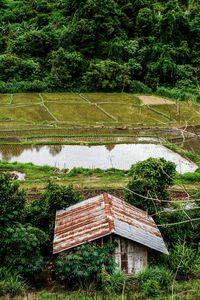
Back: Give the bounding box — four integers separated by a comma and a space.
0, 174, 46, 279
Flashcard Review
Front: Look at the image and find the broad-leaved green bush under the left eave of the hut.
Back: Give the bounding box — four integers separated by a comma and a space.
57, 243, 116, 286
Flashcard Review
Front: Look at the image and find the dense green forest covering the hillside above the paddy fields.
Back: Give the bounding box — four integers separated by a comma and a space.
0, 0, 200, 94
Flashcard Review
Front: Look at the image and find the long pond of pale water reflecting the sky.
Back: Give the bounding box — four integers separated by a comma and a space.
0, 143, 197, 173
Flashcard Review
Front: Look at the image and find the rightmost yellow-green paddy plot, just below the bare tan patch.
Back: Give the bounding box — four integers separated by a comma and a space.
150, 103, 200, 125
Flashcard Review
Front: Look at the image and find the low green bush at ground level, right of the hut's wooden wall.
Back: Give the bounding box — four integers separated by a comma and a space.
137, 266, 173, 297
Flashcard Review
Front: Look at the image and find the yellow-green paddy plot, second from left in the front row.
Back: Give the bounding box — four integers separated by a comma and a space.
46, 102, 114, 123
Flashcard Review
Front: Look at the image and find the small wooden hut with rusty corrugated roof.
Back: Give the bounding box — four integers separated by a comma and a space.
53, 193, 168, 274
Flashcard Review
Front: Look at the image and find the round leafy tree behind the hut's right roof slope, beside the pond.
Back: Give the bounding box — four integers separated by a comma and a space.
124, 158, 176, 214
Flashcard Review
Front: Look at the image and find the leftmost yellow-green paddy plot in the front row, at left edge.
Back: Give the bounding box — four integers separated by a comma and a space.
0, 105, 53, 122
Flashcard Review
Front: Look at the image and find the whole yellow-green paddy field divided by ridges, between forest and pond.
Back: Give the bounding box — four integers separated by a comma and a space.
0, 93, 200, 143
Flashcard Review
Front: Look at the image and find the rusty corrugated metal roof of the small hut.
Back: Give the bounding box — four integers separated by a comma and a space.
53, 193, 168, 254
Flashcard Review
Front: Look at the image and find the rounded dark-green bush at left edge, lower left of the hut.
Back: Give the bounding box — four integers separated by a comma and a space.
0, 223, 46, 280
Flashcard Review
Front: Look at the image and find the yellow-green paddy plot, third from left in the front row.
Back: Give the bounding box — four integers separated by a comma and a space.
99, 103, 168, 125
